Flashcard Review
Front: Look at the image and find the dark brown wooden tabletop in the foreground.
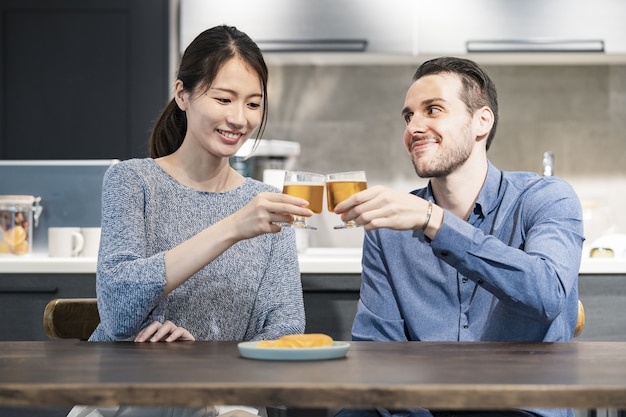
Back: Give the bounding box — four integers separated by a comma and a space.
0, 341, 626, 409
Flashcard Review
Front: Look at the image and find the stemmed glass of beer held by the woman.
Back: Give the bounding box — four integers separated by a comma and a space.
281, 171, 325, 230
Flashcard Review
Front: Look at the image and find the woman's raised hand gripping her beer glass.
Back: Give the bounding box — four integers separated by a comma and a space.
229, 193, 313, 239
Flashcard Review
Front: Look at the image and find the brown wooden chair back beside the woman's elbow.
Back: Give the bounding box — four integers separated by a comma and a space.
43, 298, 100, 340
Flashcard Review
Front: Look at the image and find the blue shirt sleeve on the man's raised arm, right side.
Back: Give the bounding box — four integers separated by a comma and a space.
431, 178, 584, 321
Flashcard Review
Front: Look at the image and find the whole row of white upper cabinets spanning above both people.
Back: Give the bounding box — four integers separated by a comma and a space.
178, 0, 626, 66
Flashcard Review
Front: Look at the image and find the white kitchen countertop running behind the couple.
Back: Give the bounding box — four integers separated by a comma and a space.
0, 248, 626, 275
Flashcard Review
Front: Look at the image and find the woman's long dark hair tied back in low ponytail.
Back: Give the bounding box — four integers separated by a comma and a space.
149, 25, 268, 158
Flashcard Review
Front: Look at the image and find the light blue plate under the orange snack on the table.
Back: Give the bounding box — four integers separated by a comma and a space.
237, 342, 350, 361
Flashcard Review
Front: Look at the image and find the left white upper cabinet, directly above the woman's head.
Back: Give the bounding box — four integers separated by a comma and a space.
179, 0, 416, 54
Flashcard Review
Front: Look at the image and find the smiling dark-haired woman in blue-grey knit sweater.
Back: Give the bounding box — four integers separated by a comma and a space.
90, 26, 312, 342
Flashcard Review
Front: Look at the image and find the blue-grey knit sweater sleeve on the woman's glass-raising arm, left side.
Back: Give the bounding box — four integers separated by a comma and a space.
96, 163, 165, 340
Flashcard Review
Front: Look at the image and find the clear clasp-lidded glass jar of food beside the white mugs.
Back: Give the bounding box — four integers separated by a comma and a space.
0, 195, 42, 255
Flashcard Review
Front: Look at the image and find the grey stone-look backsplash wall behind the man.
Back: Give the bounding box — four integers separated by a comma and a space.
264, 59, 626, 246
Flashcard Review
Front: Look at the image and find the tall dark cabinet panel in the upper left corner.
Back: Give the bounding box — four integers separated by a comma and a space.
0, 0, 169, 159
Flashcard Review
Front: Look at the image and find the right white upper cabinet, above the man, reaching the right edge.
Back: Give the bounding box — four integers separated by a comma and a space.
416, 0, 626, 55
